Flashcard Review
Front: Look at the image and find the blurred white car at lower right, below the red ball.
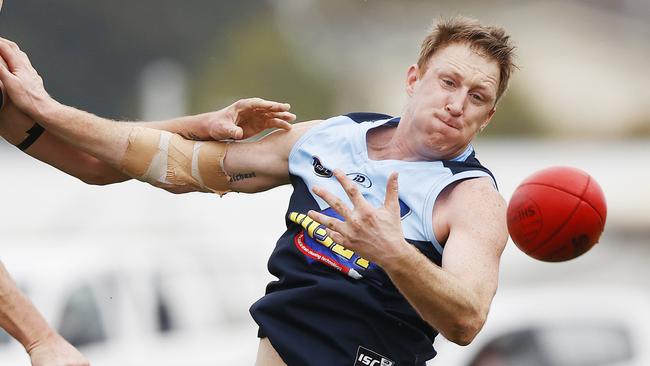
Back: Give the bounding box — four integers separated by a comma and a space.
428, 286, 650, 366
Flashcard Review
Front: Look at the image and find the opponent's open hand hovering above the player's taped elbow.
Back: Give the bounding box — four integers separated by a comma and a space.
205, 98, 296, 140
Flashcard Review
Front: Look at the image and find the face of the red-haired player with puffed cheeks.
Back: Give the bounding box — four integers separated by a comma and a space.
404, 43, 499, 159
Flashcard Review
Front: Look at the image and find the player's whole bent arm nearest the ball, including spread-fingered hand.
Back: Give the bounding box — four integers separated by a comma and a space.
309, 170, 508, 345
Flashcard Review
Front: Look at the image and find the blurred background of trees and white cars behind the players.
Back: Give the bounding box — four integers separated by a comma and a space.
0, 0, 650, 366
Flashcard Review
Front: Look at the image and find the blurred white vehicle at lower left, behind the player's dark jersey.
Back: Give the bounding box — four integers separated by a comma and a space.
0, 243, 263, 366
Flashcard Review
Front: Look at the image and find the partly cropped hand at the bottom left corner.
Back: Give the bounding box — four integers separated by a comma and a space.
27, 332, 90, 366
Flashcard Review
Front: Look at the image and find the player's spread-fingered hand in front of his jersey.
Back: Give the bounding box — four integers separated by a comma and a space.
308, 169, 410, 266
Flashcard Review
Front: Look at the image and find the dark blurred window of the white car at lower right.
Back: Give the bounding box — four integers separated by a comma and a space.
468, 324, 634, 366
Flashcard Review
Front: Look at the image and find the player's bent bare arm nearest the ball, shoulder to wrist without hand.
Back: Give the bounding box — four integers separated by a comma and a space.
384, 178, 508, 345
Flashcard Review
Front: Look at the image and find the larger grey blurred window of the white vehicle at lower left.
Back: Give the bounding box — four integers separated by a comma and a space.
58, 286, 106, 347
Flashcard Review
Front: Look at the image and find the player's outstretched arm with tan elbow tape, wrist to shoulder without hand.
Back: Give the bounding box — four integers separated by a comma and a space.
26, 102, 310, 193
